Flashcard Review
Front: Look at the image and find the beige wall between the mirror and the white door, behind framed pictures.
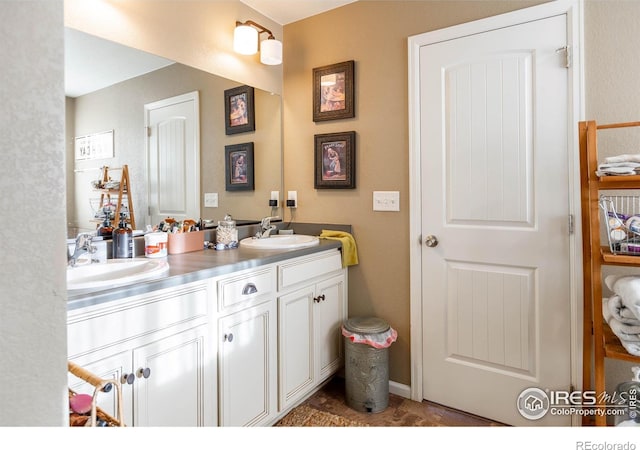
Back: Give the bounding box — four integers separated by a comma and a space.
283, 1, 543, 385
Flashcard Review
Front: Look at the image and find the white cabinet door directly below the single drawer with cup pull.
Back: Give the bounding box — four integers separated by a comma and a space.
218, 301, 278, 426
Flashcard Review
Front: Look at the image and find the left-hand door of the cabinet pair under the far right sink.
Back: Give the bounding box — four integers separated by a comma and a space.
278, 286, 315, 411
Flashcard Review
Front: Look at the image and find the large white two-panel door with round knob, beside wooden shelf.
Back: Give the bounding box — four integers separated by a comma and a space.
419, 15, 571, 426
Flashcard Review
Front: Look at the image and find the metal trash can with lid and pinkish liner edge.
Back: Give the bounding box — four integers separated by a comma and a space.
342, 317, 397, 413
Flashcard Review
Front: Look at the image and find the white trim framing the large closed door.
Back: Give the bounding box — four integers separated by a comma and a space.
408, 0, 584, 418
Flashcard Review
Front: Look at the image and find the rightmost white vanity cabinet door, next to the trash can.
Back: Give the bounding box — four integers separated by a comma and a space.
313, 274, 347, 383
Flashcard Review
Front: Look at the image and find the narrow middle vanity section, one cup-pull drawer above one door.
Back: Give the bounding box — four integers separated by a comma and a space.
217, 265, 278, 426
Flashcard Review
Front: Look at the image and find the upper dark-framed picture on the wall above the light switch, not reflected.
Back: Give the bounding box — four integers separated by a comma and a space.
313, 61, 355, 122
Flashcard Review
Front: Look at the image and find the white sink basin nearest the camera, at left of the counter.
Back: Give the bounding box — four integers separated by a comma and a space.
67, 258, 169, 290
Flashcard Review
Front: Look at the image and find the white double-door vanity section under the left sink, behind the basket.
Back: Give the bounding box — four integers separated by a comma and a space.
68, 282, 217, 426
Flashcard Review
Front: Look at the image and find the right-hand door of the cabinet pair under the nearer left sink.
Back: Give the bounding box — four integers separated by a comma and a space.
132, 325, 215, 427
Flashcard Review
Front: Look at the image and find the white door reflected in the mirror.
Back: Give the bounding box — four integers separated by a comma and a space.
144, 91, 200, 225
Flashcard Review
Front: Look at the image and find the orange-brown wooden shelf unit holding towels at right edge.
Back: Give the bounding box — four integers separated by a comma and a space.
578, 121, 640, 426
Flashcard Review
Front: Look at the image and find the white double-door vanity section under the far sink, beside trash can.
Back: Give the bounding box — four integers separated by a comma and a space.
278, 251, 347, 411
